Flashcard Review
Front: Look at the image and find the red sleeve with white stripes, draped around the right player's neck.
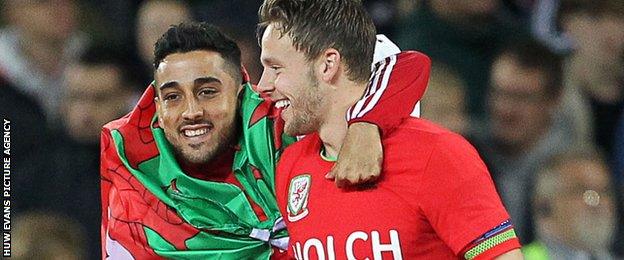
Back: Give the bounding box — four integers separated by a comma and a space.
347, 51, 431, 134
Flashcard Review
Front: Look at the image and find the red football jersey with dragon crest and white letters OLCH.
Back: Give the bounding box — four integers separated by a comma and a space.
276, 118, 520, 259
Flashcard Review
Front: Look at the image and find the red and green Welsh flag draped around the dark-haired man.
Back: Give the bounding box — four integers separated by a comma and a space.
100, 70, 294, 259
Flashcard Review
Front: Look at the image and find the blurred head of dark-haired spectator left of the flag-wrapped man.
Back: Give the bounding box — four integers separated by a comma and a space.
63, 46, 137, 144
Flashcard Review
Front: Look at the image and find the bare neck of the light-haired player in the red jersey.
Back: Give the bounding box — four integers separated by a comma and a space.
319, 81, 366, 157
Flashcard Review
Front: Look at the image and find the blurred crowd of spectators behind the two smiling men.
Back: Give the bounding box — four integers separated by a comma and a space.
0, 0, 624, 259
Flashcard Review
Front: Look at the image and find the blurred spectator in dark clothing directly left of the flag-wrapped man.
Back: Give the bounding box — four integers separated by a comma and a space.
47, 46, 137, 259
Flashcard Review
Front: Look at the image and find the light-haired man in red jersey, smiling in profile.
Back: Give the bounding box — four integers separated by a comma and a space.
259, 0, 522, 259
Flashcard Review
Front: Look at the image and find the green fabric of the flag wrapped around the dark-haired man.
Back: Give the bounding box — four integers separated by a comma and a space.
103, 83, 295, 259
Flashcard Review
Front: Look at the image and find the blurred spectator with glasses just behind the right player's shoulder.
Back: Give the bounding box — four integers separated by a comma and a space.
472, 40, 570, 243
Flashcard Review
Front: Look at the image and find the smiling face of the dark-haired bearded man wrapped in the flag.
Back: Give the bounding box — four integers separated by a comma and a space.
155, 51, 241, 164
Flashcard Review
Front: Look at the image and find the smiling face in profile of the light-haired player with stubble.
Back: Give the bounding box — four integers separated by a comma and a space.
258, 24, 328, 136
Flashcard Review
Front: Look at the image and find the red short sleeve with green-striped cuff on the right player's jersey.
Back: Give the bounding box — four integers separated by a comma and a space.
419, 133, 520, 259
